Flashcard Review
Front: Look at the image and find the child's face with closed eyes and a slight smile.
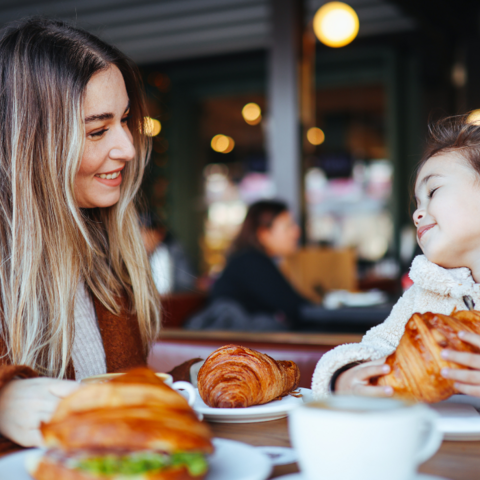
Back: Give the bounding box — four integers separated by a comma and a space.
413, 152, 480, 268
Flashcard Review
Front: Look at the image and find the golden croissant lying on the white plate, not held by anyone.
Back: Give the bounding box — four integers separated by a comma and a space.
198, 345, 300, 408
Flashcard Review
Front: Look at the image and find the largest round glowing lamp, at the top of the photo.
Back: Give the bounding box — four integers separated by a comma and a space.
313, 2, 360, 48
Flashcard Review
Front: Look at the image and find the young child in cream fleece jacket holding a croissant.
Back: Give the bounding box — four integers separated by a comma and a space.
312, 117, 480, 399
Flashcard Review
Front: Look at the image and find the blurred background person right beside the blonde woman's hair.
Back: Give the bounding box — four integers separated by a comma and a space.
140, 212, 195, 295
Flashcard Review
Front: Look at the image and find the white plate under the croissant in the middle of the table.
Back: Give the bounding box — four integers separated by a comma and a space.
193, 388, 311, 423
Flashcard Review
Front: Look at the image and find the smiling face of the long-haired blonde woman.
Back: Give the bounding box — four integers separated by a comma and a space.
75, 65, 135, 208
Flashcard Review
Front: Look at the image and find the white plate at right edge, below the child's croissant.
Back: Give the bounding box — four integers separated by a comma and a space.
430, 395, 480, 441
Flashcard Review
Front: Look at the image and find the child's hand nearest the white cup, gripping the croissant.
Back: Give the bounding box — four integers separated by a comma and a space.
335, 358, 393, 397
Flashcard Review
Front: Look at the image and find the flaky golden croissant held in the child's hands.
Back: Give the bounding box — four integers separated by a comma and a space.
371, 311, 480, 403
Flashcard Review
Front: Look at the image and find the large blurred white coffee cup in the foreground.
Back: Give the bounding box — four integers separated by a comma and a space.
288, 396, 442, 480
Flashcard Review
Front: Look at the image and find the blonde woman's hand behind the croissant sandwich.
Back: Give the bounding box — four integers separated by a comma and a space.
0, 378, 79, 447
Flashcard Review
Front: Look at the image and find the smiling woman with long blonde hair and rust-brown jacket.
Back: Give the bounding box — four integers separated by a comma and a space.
0, 18, 159, 451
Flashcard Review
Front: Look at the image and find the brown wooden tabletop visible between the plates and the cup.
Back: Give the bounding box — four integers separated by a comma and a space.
210, 418, 480, 480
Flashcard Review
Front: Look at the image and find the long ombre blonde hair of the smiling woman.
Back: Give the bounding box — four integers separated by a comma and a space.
0, 18, 159, 378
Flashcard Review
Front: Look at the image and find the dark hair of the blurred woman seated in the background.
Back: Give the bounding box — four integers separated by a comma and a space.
230, 200, 288, 254
